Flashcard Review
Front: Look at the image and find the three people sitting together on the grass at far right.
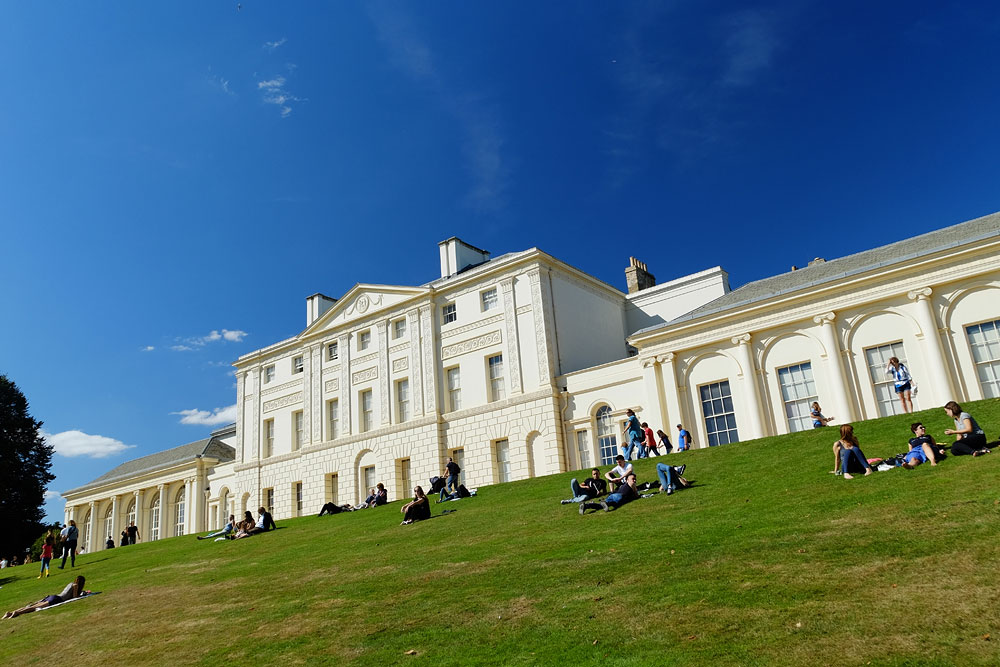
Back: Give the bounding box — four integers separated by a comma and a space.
831, 402, 990, 479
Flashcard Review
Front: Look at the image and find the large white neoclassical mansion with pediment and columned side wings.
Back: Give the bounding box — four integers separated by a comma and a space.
64, 214, 1000, 549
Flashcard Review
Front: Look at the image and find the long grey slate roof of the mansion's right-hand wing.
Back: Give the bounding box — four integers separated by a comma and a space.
633, 213, 1000, 335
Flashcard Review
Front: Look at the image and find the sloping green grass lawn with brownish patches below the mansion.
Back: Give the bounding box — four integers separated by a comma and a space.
0, 400, 1000, 665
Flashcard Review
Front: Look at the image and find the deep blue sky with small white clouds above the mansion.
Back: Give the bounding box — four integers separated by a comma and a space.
0, 0, 1000, 518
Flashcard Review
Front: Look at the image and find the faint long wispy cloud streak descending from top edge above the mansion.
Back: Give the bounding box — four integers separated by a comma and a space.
368, 3, 511, 212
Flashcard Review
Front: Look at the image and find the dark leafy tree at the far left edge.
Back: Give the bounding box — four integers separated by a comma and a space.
0, 375, 55, 558
